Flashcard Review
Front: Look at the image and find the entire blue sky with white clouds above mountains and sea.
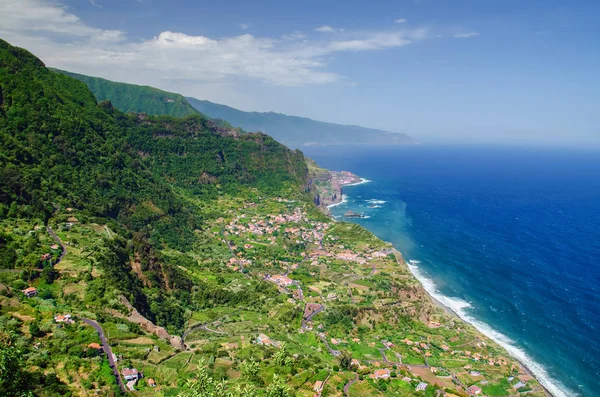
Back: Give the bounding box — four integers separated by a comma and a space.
0, 0, 600, 145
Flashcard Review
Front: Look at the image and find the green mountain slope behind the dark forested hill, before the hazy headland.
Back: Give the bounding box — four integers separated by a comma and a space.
53, 69, 197, 117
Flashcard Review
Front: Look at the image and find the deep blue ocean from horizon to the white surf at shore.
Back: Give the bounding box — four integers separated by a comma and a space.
305, 146, 600, 397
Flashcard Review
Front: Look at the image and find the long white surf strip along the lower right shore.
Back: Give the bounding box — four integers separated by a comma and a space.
408, 261, 580, 397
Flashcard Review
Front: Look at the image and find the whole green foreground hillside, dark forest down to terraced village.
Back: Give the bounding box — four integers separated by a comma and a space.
0, 40, 543, 397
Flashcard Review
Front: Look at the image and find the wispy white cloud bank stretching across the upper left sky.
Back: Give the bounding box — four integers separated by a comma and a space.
0, 0, 454, 93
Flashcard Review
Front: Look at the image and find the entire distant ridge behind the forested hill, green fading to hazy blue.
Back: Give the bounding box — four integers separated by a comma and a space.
53, 69, 414, 149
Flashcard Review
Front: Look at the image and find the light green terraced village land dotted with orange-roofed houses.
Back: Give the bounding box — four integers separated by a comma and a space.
0, 198, 543, 397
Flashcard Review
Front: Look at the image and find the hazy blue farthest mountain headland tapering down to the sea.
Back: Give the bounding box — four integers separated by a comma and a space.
187, 97, 413, 148
